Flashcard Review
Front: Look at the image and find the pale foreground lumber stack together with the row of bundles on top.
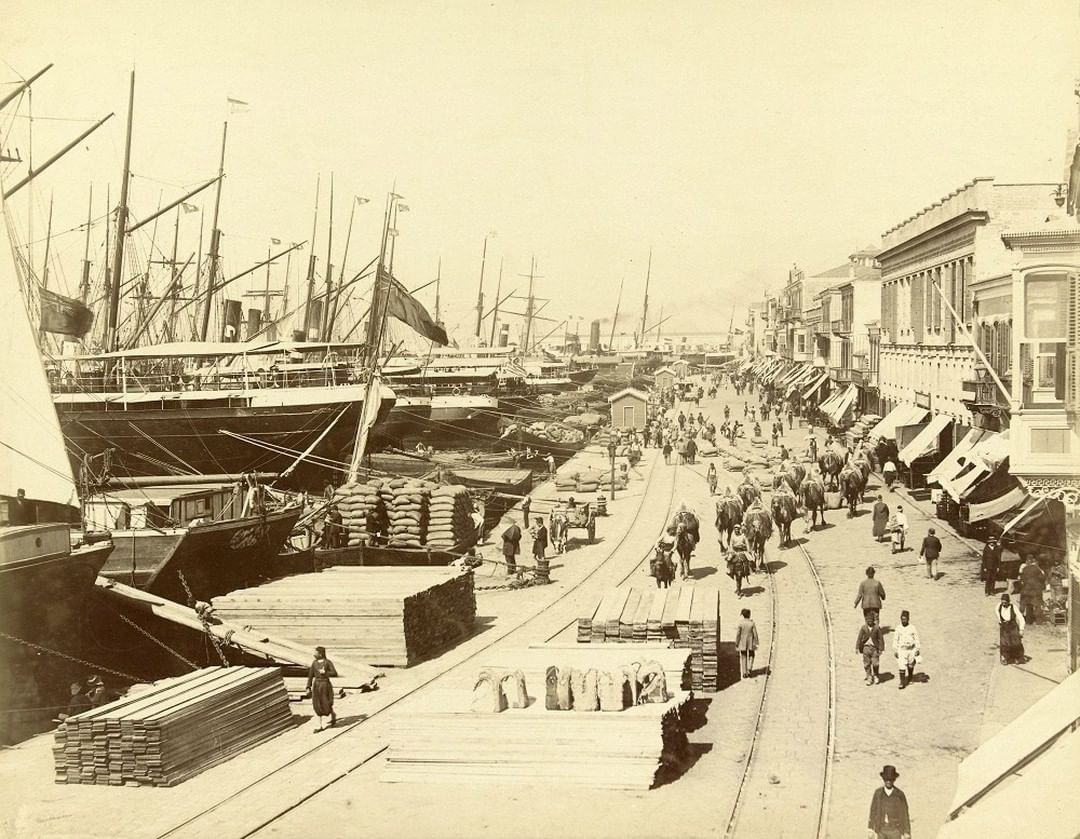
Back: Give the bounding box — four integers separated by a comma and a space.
381, 644, 690, 790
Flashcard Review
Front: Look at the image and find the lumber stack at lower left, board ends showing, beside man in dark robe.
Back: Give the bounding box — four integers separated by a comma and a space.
53, 667, 293, 786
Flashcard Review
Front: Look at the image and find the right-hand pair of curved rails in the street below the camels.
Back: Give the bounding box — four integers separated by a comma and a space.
724, 516, 836, 839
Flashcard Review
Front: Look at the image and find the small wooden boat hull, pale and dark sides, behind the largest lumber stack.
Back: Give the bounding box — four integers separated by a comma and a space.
102, 505, 301, 604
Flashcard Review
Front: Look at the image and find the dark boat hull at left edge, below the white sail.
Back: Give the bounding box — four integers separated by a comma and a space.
0, 525, 112, 743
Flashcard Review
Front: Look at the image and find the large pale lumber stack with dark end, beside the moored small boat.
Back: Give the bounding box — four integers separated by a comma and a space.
214, 566, 476, 667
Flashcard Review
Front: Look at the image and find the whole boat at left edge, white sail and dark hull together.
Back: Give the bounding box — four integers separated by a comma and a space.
0, 75, 112, 742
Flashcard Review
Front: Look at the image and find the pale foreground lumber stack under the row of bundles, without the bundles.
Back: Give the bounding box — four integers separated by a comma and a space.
382, 645, 689, 790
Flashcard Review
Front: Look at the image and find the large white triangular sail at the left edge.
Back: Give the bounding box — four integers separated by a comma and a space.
0, 201, 79, 506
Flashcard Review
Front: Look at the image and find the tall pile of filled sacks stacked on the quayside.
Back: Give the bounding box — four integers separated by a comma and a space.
334, 478, 476, 550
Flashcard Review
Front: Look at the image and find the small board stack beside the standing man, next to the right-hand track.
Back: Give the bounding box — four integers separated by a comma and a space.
578, 585, 720, 691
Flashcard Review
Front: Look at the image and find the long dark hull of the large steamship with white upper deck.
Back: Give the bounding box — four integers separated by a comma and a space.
55, 389, 393, 489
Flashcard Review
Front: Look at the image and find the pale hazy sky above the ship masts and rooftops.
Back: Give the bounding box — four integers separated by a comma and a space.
0, 0, 1080, 337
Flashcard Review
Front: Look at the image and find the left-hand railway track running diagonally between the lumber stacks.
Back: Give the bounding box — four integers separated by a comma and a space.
156, 449, 677, 839
